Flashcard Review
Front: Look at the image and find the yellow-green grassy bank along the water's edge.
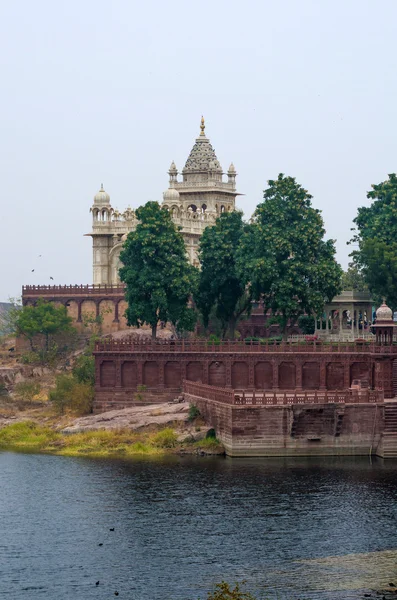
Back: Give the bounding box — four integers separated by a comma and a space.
0, 421, 222, 458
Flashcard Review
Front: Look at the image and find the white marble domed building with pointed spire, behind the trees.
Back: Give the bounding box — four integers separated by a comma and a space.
88, 118, 239, 284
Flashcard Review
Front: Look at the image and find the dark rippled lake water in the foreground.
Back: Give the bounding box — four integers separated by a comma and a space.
0, 452, 397, 600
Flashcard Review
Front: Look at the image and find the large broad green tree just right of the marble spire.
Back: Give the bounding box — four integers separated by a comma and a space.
239, 173, 342, 337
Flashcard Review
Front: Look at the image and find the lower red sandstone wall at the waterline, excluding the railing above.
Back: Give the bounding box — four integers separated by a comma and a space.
185, 395, 384, 456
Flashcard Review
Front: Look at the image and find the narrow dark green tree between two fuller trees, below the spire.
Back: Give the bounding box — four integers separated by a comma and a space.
195, 211, 251, 339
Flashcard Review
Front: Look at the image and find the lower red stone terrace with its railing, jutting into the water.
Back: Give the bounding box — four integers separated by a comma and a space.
184, 381, 384, 456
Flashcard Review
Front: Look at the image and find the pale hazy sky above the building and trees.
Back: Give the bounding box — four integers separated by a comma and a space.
0, 0, 397, 301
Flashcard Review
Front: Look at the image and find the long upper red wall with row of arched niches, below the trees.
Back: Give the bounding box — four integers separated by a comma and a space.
94, 339, 397, 406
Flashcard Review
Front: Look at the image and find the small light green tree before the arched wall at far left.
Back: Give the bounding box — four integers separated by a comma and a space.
10, 298, 74, 353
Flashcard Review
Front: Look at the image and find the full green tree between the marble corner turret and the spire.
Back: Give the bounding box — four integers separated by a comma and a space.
120, 202, 197, 338
